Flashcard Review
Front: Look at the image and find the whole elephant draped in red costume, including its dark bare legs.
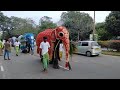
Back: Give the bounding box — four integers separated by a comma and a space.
36, 26, 71, 70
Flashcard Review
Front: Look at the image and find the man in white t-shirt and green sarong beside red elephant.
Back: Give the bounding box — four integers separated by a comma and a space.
40, 37, 50, 72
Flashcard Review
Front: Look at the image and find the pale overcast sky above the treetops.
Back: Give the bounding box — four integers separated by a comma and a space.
2, 11, 110, 24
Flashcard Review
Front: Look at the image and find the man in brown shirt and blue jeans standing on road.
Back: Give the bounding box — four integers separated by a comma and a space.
4, 39, 11, 60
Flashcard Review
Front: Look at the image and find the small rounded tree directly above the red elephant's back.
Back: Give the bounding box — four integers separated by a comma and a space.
38, 16, 57, 33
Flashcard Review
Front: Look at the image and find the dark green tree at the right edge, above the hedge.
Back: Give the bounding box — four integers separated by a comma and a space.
105, 11, 120, 38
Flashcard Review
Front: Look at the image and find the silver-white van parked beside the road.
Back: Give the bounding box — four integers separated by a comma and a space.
76, 41, 101, 57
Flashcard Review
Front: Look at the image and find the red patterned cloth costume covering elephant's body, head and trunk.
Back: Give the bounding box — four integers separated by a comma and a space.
36, 26, 70, 67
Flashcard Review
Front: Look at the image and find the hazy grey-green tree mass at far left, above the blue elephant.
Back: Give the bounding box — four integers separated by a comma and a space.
0, 12, 38, 38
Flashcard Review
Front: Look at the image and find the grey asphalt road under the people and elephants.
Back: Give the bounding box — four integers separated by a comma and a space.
0, 47, 120, 79
